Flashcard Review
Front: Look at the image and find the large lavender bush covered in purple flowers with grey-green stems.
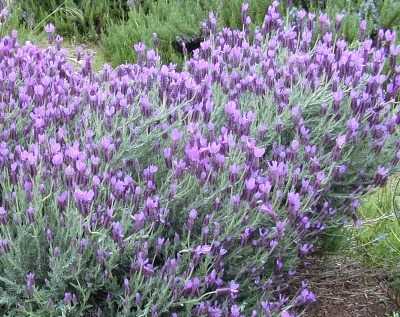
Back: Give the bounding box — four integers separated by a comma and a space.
0, 3, 400, 317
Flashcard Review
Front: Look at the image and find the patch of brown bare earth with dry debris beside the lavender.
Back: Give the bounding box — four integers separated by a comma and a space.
300, 256, 396, 317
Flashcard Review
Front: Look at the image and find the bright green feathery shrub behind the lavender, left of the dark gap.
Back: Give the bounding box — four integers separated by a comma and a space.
102, 0, 211, 65
